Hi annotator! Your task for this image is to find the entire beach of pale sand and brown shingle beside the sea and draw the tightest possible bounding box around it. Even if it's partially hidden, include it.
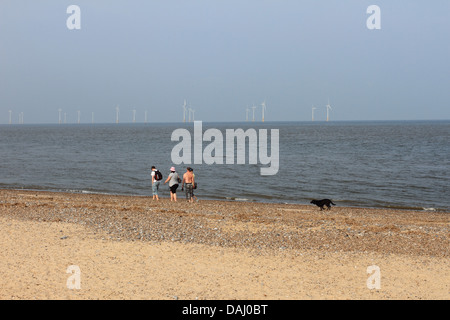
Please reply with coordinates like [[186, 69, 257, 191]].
[[0, 190, 450, 300]]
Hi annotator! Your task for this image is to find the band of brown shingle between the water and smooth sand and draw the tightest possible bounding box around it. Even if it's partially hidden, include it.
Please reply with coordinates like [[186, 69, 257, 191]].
[[0, 190, 450, 257]]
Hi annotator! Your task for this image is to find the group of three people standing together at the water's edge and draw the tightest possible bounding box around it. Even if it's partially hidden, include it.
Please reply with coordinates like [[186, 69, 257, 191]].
[[151, 166, 196, 202]]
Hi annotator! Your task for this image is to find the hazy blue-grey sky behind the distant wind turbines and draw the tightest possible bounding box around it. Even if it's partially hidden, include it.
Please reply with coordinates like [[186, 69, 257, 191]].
[[0, 0, 450, 124]]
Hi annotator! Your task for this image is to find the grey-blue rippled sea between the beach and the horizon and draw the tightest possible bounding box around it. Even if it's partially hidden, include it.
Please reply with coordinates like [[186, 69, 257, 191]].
[[0, 121, 450, 210]]
